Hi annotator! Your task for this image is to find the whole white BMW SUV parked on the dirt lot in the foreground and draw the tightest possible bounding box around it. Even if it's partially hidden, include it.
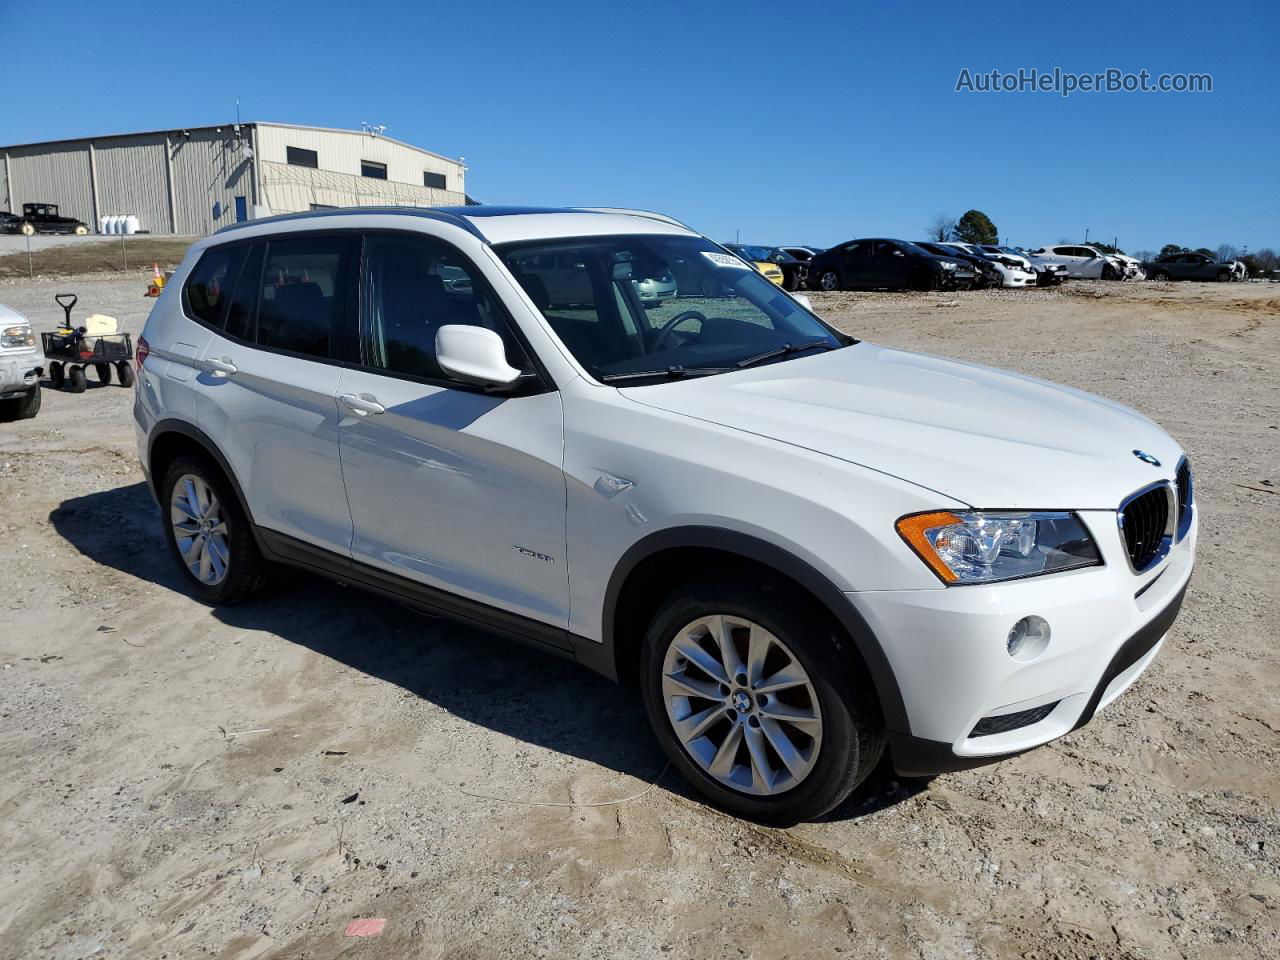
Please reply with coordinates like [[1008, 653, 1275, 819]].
[[136, 206, 1196, 823]]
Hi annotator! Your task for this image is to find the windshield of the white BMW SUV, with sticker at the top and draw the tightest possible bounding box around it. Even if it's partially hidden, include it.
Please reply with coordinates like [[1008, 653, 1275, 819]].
[[495, 236, 850, 383]]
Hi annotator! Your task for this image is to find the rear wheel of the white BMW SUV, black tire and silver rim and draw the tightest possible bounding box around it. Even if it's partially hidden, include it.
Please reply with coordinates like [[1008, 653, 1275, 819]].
[[160, 457, 266, 604]]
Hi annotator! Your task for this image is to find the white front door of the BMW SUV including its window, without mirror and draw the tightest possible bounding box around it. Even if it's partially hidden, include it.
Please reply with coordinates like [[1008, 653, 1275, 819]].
[[338, 233, 568, 627]]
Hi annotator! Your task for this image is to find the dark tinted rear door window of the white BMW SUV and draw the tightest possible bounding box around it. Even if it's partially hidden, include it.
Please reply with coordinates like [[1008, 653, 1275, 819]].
[[257, 234, 351, 358]]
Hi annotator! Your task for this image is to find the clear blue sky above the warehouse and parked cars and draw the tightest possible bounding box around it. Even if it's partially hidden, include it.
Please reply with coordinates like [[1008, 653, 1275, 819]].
[[0, 0, 1280, 250]]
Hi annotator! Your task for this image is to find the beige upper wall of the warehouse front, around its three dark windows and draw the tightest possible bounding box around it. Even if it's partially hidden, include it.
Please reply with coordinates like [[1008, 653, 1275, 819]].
[[257, 123, 466, 195]]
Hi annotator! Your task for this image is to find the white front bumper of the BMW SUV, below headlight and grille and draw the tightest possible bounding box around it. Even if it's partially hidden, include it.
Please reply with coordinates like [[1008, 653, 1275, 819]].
[[849, 511, 1197, 776]]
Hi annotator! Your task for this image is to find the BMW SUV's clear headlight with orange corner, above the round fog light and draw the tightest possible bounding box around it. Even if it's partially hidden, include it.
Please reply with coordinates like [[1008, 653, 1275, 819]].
[[897, 511, 1102, 584]]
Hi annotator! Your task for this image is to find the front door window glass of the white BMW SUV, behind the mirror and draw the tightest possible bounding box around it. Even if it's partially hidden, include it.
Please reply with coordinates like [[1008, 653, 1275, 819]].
[[361, 234, 529, 380]]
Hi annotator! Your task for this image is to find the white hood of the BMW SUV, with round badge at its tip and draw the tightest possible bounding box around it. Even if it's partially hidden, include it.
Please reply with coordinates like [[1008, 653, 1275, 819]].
[[621, 343, 1181, 509]]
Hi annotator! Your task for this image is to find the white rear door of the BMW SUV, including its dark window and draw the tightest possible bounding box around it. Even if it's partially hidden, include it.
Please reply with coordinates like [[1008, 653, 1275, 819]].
[[197, 233, 356, 557]]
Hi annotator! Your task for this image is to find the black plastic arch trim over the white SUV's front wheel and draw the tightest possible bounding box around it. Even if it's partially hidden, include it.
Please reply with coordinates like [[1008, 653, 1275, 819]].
[[602, 526, 911, 733]]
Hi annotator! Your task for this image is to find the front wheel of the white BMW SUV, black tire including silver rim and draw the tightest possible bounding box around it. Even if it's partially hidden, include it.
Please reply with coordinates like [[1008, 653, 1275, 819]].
[[641, 581, 884, 826]]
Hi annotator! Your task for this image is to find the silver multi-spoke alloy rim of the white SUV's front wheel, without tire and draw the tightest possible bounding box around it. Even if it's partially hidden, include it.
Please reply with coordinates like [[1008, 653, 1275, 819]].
[[662, 614, 822, 796]]
